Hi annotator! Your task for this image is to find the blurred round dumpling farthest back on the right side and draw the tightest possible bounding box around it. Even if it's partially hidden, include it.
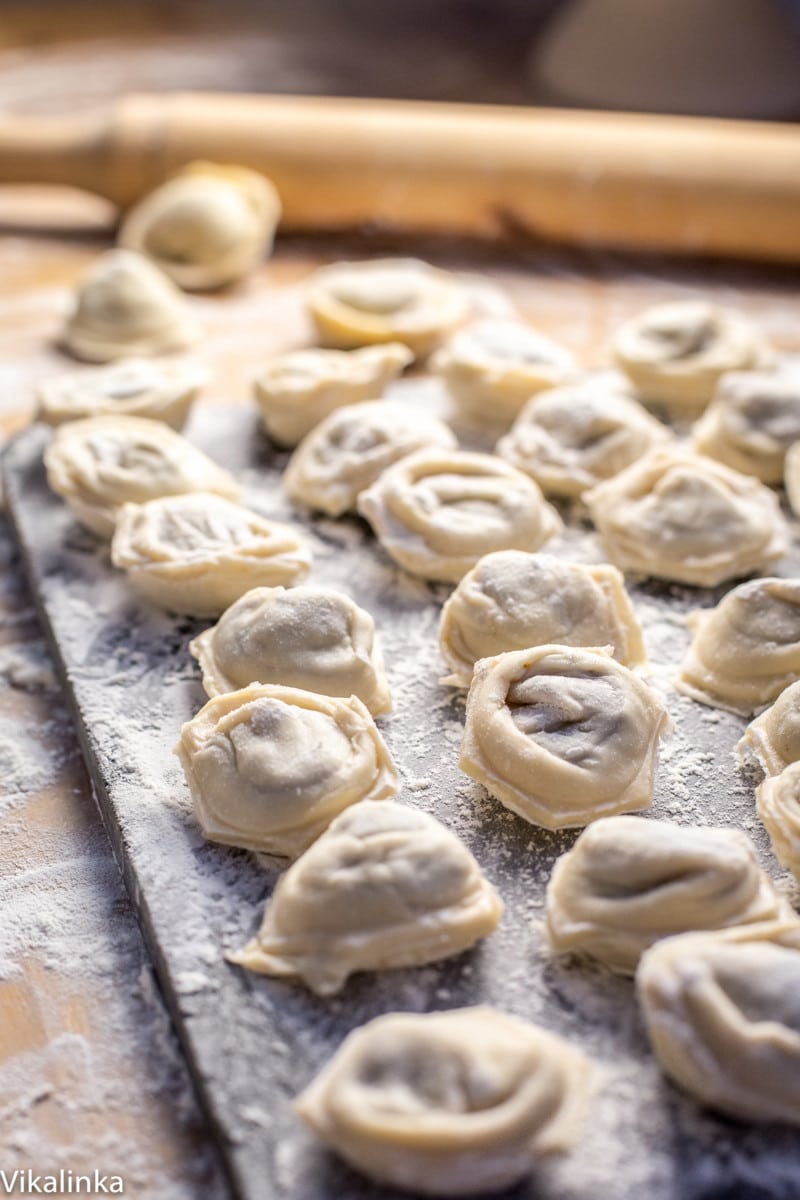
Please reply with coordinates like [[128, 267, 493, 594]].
[[614, 300, 765, 413]]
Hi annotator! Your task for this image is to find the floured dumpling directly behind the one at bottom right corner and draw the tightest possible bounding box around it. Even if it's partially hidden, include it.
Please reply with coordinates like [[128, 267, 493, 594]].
[[547, 817, 790, 974]]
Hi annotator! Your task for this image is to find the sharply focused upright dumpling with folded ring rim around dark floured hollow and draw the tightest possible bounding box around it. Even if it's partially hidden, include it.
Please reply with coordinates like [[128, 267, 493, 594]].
[[459, 646, 668, 829]]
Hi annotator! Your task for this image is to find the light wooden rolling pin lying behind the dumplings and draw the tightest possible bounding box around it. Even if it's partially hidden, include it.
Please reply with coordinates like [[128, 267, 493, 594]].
[[0, 92, 800, 263]]
